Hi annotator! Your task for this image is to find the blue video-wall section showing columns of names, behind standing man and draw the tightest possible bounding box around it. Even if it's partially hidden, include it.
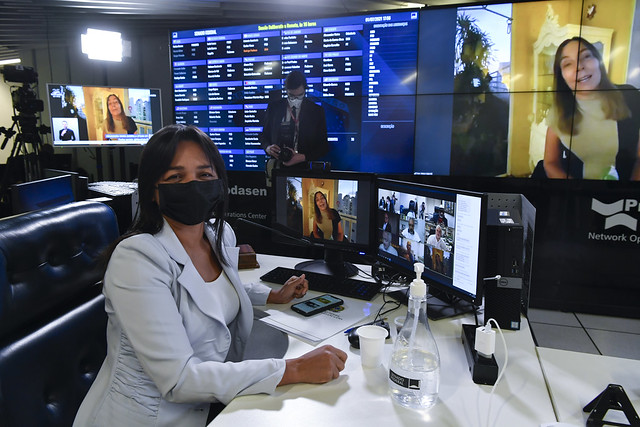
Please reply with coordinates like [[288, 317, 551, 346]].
[[171, 11, 419, 173]]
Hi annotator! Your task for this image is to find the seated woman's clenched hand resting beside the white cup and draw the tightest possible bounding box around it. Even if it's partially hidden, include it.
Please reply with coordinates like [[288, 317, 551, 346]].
[[278, 345, 347, 385]]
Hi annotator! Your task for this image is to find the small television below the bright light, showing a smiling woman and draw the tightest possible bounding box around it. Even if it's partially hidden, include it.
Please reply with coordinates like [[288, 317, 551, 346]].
[[47, 83, 162, 147]]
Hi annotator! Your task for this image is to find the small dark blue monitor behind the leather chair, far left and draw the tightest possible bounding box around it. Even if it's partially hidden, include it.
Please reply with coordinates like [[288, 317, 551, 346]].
[[11, 175, 75, 214]]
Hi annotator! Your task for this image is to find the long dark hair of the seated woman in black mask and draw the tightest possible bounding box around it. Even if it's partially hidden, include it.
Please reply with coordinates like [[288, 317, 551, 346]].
[[104, 125, 234, 267]]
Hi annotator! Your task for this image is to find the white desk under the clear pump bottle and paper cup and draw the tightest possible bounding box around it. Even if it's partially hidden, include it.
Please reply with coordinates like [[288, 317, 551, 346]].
[[209, 255, 556, 427]]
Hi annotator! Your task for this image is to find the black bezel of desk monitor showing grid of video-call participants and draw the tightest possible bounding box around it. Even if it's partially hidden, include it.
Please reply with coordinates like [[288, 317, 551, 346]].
[[372, 177, 488, 307]]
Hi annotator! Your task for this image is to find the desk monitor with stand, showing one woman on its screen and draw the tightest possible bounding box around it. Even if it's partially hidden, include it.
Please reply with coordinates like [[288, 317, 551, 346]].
[[272, 169, 374, 277]]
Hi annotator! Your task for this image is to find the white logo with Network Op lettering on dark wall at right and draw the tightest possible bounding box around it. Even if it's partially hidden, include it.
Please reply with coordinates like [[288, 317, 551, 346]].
[[587, 198, 640, 244]]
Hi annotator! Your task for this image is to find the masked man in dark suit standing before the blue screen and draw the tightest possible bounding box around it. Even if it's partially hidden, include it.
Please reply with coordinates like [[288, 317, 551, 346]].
[[260, 70, 329, 182]]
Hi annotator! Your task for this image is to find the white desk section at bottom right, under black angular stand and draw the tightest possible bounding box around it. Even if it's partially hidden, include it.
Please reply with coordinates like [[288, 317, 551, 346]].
[[538, 347, 640, 426]]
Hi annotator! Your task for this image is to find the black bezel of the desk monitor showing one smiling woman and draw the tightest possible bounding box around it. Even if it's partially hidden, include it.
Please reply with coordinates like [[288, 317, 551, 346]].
[[270, 168, 376, 255]]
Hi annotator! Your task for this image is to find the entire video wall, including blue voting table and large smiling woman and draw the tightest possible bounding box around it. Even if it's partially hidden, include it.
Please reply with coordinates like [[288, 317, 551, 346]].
[[171, 0, 640, 181]]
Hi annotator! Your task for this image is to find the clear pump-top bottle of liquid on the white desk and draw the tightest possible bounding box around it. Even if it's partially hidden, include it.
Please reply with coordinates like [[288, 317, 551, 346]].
[[389, 263, 440, 409]]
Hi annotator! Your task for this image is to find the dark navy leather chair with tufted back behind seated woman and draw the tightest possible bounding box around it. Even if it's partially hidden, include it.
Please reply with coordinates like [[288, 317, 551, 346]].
[[0, 202, 118, 426]]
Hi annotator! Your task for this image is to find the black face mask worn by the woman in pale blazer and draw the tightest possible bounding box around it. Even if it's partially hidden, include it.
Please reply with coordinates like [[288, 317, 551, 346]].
[[158, 179, 223, 225]]
